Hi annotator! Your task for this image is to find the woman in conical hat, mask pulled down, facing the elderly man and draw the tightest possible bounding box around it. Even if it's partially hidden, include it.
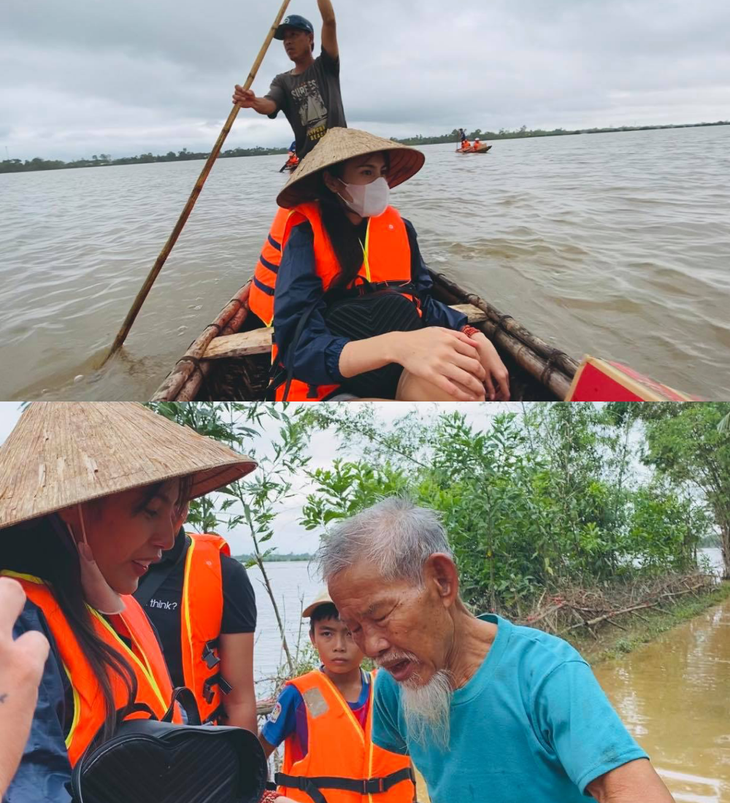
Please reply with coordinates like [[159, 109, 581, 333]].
[[0, 402, 255, 803]]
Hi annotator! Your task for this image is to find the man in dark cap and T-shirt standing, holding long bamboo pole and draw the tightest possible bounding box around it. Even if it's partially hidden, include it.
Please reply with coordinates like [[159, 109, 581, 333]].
[[233, 0, 347, 159]]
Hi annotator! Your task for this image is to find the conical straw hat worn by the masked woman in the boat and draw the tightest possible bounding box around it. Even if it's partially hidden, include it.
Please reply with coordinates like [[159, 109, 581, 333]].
[[276, 128, 426, 209]]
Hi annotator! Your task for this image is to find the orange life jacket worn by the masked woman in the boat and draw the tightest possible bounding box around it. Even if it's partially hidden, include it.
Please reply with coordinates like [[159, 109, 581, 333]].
[[272, 202, 412, 401]]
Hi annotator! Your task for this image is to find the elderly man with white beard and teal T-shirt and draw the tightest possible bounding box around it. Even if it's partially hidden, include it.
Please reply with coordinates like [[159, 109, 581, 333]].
[[319, 499, 672, 803]]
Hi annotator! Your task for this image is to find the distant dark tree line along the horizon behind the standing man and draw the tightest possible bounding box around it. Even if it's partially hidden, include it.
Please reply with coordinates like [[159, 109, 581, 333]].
[[0, 120, 730, 173]]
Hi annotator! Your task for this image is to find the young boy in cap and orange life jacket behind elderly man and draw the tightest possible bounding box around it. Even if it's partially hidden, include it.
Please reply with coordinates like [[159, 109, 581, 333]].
[[259, 593, 415, 803]]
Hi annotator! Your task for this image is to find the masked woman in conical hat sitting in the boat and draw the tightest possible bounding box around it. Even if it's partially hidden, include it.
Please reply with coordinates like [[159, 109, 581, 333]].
[[257, 128, 509, 401]]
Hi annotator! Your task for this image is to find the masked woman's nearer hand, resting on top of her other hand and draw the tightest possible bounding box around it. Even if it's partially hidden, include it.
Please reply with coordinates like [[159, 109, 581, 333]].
[[389, 326, 487, 401]]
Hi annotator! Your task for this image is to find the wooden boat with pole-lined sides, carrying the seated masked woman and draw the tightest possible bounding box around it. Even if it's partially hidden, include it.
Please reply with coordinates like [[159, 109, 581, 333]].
[[153, 271, 578, 401]]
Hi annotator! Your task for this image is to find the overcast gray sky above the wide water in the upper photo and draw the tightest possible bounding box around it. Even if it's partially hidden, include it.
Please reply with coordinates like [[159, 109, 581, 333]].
[[0, 0, 730, 159]]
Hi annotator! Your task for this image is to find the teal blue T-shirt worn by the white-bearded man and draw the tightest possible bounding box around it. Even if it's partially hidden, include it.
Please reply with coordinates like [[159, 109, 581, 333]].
[[373, 614, 648, 803]]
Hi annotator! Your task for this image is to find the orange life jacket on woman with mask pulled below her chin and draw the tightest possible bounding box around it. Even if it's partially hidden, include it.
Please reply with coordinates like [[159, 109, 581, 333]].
[[2, 571, 182, 767]]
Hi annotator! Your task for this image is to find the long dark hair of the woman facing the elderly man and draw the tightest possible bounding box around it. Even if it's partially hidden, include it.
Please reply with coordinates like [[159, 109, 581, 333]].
[[0, 477, 192, 743]]
